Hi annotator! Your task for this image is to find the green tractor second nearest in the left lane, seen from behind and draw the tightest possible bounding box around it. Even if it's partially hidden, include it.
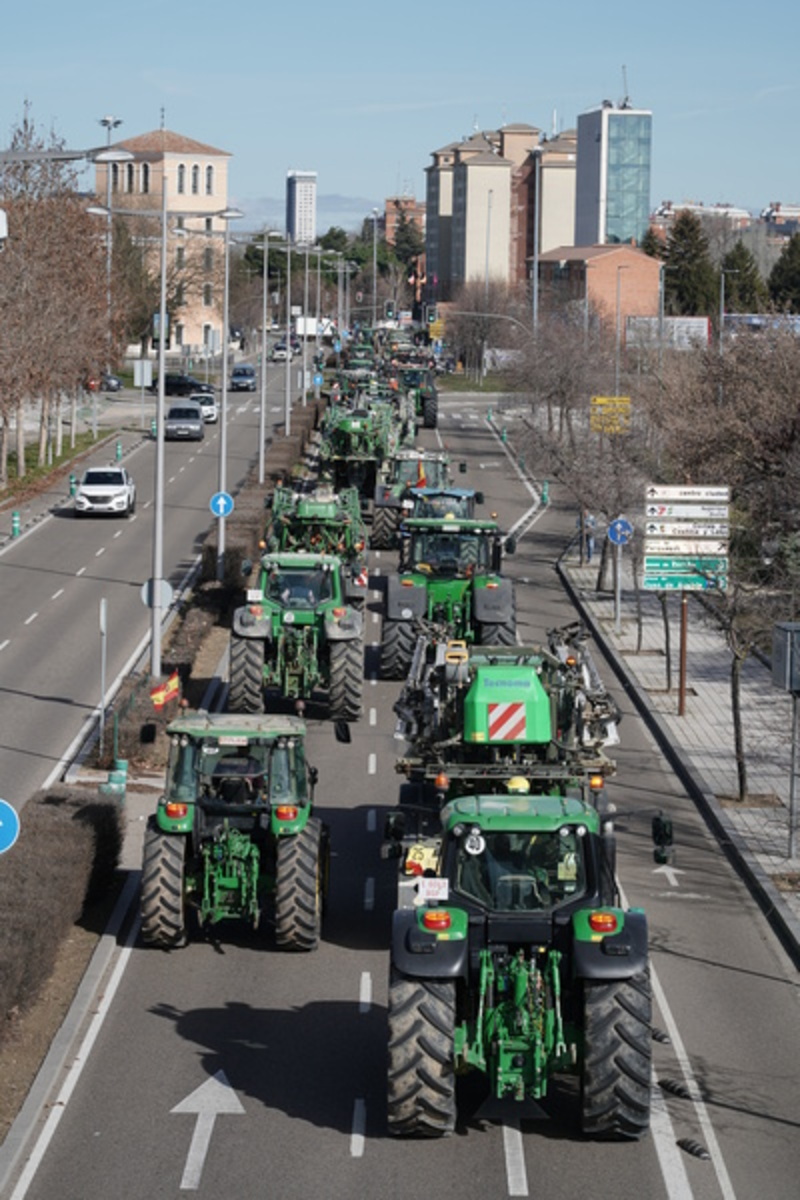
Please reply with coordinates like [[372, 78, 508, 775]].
[[228, 551, 363, 721]]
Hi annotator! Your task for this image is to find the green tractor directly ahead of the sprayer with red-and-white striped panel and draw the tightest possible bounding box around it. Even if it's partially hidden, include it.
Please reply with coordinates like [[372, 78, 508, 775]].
[[380, 517, 517, 679]]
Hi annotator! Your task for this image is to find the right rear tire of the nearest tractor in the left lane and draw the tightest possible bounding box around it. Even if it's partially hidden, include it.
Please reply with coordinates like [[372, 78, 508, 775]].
[[275, 817, 327, 950]]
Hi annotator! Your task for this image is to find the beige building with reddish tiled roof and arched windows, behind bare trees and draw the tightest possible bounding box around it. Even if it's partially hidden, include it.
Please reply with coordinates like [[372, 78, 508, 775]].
[[95, 130, 230, 358]]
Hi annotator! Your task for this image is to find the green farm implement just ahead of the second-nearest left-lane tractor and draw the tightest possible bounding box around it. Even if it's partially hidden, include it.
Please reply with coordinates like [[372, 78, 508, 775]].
[[266, 484, 369, 610]]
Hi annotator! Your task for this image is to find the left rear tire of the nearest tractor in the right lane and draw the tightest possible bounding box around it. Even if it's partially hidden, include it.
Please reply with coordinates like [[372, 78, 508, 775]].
[[387, 967, 456, 1138]]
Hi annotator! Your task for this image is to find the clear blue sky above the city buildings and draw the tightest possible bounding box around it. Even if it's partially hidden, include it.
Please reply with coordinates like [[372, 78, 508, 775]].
[[0, 0, 800, 232]]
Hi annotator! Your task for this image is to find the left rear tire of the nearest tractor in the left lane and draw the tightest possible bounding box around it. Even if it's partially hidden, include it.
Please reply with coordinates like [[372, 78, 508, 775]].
[[140, 817, 187, 950]]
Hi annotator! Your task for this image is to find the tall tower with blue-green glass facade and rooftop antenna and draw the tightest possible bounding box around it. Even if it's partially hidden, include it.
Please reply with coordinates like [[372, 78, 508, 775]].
[[575, 101, 652, 246]]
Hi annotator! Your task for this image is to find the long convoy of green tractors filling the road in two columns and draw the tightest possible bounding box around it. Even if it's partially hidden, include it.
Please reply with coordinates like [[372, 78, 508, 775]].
[[136, 326, 651, 1139]]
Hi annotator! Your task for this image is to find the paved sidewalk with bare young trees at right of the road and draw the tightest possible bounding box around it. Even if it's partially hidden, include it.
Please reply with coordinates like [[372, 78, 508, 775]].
[[559, 546, 800, 966]]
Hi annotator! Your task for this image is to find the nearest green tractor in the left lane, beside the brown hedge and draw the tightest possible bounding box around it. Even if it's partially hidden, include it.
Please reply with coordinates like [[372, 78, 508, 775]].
[[142, 712, 329, 950]]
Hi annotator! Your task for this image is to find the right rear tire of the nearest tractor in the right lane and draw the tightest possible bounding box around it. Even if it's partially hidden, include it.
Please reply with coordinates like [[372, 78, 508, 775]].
[[581, 970, 652, 1139]]
